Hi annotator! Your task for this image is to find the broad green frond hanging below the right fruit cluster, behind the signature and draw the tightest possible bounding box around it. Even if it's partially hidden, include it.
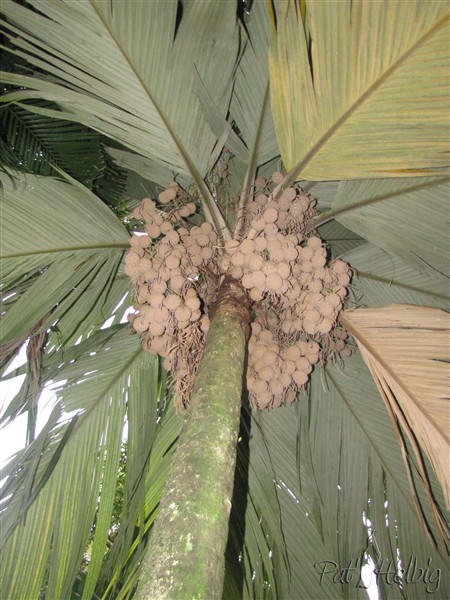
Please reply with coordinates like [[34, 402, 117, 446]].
[[251, 355, 447, 599]]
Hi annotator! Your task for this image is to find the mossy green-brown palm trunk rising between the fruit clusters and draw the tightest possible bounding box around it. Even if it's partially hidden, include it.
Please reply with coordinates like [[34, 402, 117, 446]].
[[136, 278, 250, 600]]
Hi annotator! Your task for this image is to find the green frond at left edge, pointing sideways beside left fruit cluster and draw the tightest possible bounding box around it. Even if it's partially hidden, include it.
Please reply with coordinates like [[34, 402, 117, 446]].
[[0, 169, 129, 354]]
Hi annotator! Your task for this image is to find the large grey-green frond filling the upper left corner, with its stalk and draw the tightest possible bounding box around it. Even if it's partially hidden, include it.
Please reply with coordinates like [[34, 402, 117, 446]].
[[3, 0, 239, 236]]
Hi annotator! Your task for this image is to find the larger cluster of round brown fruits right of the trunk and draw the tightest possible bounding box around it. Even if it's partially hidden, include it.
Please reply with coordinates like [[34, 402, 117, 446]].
[[222, 176, 351, 409]]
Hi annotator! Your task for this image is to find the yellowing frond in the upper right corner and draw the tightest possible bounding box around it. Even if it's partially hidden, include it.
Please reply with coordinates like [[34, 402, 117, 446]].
[[270, 0, 449, 180]]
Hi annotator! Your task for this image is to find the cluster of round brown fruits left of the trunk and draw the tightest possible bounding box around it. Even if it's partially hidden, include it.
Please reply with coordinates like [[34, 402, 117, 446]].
[[125, 187, 219, 404]]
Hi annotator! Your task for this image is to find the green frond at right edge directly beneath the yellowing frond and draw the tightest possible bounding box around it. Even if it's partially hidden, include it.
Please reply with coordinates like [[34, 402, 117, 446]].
[[316, 177, 449, 274]]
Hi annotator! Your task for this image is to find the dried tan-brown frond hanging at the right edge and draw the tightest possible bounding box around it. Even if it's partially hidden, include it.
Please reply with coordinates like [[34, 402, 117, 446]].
[[340, 304, 450, 507]]
